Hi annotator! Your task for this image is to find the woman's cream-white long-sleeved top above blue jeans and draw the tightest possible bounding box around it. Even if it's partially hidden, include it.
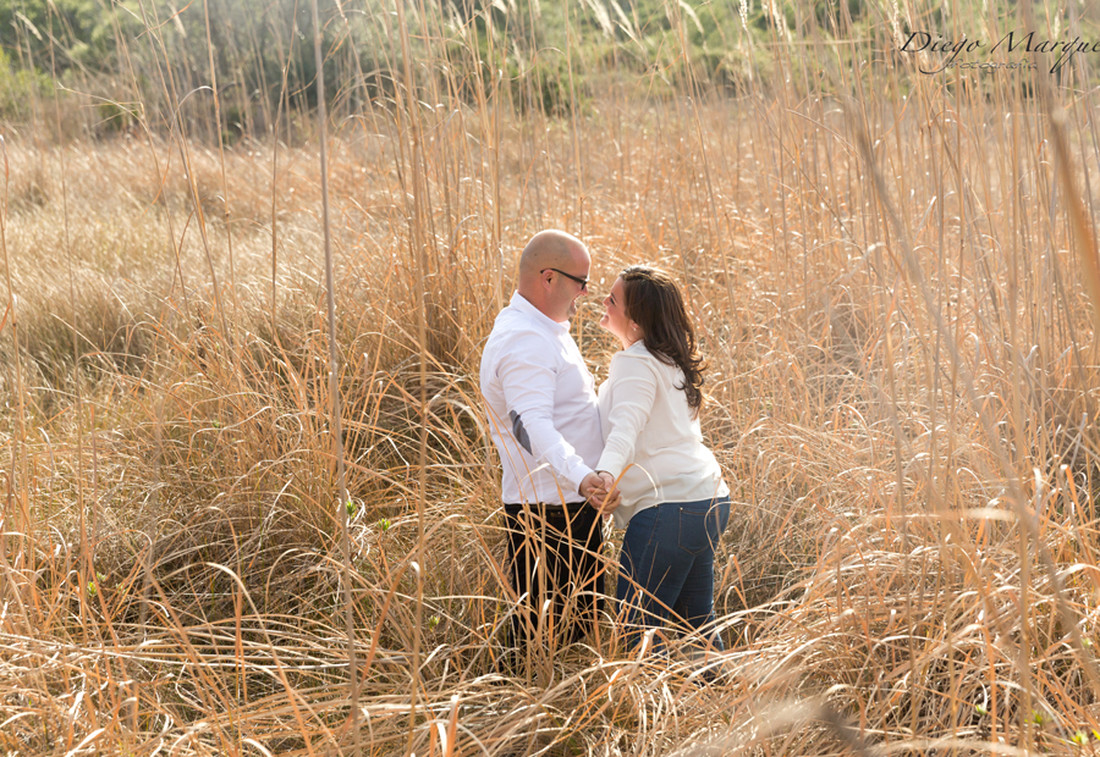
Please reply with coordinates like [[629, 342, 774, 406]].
[[596, 340, 729, 528]]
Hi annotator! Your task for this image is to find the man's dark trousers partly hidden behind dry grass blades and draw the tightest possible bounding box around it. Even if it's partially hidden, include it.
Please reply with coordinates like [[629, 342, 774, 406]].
[[504, 503, 604, 648]]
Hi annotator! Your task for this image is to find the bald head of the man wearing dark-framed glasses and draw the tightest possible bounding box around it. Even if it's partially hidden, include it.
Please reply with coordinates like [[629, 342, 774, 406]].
[[518, 229, 592, 322]]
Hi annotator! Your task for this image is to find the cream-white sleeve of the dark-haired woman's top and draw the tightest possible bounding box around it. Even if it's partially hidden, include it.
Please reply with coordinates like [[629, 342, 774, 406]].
[[596, 352, 657, 478]]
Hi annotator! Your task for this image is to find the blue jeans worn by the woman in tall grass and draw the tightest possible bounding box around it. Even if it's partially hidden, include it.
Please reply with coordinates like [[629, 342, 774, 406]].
[[615, 496, 729, 649]]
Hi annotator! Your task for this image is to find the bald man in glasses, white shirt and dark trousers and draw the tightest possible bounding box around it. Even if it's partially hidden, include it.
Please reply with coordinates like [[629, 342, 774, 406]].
[[481, 229, 617, 645]]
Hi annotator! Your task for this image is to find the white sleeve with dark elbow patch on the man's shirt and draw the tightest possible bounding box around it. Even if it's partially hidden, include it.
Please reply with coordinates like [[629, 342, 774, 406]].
[[497, 340, 592, 494]]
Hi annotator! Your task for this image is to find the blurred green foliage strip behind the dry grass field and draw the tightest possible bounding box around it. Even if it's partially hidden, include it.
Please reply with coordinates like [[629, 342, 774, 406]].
[[0, 0, 1100, 141]]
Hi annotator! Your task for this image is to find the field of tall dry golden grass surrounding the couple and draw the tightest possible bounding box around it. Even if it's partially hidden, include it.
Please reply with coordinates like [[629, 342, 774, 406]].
[[0, 3, 1100, 757]]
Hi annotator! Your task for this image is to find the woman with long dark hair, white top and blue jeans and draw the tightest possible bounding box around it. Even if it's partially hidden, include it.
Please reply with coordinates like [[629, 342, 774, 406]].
[[596, 265, 729, 649]]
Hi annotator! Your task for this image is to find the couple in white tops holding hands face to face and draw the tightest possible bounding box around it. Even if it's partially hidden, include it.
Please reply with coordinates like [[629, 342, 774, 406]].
[[481, 230, 729, 649]]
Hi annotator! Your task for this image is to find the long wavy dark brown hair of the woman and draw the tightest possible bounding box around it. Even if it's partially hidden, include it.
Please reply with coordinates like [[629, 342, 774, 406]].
[[619, 265, 706, 415]]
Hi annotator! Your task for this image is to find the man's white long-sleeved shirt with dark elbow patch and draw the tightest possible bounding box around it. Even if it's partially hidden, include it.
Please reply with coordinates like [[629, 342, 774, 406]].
[[481, 292, 603, 504]]
